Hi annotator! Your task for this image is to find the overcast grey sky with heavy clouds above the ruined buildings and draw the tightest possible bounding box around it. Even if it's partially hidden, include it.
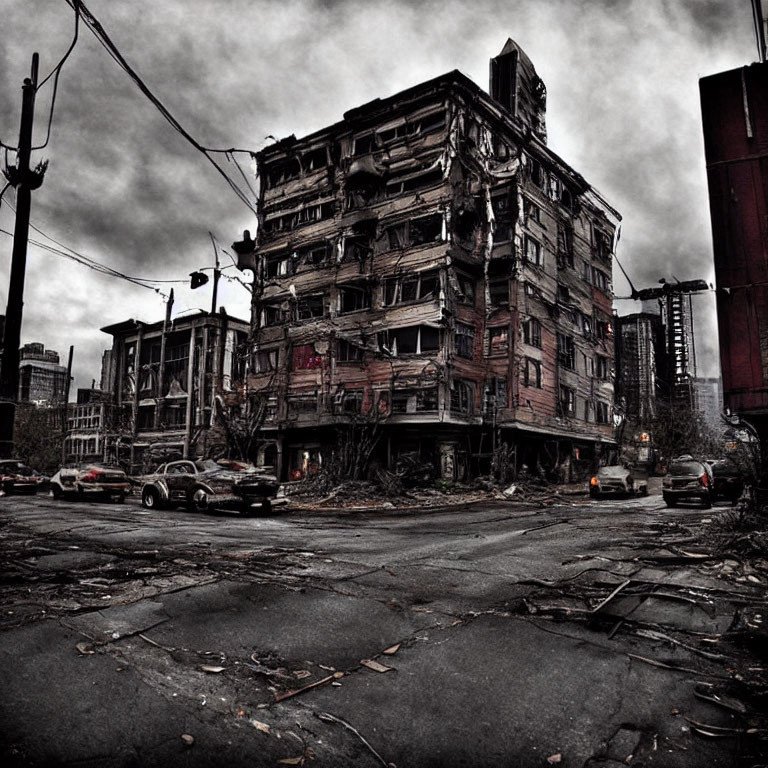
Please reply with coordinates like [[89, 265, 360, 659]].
[[0, 0, 756, 387]]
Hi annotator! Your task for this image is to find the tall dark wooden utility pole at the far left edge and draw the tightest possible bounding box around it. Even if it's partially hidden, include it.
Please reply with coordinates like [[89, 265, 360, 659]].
[[0, 53, 45, 458]]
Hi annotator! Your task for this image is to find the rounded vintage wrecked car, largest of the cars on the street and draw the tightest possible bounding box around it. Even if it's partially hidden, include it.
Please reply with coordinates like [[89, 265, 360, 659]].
[[141, 459, 280, 515]]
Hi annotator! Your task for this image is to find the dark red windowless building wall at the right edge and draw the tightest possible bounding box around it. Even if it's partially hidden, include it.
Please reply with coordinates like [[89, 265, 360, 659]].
[[699, 62, 768, 444]]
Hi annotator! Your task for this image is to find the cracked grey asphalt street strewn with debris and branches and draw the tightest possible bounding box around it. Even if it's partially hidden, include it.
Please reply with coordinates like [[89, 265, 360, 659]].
[[0, 495, 768, 768]]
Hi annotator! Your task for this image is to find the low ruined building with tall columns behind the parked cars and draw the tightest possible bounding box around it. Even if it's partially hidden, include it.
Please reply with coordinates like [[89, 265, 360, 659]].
[[102, 311, 249, 471]]
